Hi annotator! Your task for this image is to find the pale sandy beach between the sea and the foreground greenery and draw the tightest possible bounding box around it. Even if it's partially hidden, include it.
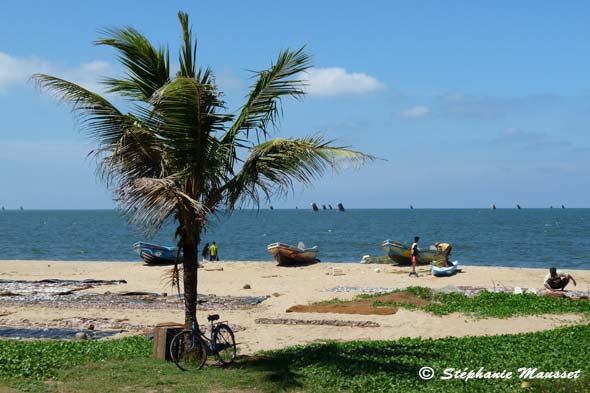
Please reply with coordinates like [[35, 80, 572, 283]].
[[0, 260, 590, 354]]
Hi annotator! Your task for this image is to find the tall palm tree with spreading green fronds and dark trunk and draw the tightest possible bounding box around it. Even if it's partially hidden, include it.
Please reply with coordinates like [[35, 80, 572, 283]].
[[32, 12, 373, 327]]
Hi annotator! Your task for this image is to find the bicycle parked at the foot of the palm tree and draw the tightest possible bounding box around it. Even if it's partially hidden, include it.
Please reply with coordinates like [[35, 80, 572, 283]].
[[170, 314, 236, 371]]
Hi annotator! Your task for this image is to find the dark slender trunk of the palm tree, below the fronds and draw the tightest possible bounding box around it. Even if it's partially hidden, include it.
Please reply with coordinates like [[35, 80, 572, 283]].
[[182, 226, 201, 329]]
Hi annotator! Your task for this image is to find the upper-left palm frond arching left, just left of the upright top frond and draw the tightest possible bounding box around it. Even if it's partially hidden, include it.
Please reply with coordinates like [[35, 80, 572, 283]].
[[95, 27, 170, 101]]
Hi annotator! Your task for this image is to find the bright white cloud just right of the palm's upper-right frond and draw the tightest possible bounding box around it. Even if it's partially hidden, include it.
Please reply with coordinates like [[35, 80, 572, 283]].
[[305, 67, 385, 96]]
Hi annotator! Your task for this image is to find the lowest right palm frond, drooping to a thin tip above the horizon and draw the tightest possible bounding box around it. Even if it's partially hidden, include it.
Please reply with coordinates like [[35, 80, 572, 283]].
[[227, 135, 376, 208]]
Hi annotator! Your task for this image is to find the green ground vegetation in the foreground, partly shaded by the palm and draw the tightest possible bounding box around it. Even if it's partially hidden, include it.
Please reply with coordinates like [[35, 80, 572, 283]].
[[0, 325, 590, 393]]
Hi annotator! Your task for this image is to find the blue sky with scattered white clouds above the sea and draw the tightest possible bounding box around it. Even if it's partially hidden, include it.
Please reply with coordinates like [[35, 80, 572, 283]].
[[0, 0, 590, 209]]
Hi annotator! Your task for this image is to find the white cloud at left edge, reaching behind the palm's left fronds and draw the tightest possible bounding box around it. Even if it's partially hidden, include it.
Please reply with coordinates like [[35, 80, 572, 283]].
[[0, 52, 114, 93]]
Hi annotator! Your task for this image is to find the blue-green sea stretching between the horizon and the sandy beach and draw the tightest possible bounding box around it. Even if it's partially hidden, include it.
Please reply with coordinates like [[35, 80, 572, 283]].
[[0, 208, 590, 269]]
